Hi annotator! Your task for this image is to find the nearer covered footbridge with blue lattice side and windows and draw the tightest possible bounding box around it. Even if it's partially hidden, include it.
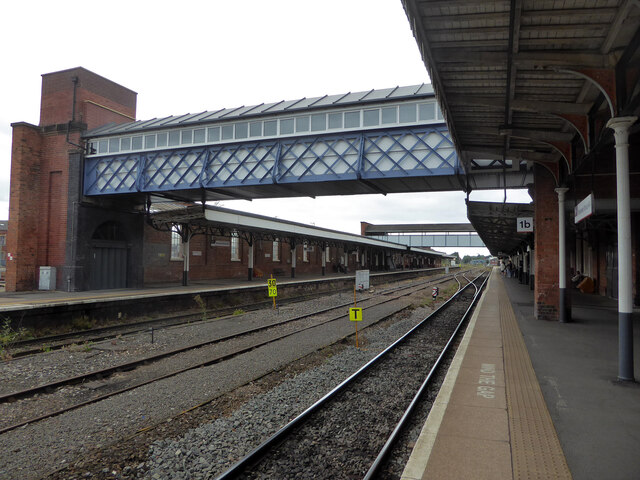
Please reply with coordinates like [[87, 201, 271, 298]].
[[83, 84, 531, 201]]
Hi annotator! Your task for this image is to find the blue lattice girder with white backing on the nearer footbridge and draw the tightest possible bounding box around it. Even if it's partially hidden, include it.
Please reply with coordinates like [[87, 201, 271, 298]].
[[84, 125, 459, 195]]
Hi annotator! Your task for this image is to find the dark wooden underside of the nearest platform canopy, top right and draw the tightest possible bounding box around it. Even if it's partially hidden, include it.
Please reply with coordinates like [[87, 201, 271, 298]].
[[403, 0, 640, 190]]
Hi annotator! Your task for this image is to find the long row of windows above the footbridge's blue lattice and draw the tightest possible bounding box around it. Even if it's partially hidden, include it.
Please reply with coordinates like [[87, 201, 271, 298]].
[[91, 102, 442, 154]]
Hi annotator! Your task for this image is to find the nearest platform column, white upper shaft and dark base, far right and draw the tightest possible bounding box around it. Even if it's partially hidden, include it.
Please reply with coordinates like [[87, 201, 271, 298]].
[[607, 117, 638, 381]]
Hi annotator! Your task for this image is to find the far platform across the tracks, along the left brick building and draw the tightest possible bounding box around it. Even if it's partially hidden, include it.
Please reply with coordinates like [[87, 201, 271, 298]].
[[0, 267, 444, 326]]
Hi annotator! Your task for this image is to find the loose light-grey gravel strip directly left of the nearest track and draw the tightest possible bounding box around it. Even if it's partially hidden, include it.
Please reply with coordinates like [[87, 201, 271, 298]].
[[144, 300, 462, 480]]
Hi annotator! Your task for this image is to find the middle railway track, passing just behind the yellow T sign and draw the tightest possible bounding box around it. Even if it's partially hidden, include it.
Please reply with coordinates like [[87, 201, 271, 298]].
[[0, 270, 470, 434]]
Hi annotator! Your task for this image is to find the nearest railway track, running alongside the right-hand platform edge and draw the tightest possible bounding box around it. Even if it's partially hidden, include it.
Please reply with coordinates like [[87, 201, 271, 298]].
[[212, 275, 486, 480]]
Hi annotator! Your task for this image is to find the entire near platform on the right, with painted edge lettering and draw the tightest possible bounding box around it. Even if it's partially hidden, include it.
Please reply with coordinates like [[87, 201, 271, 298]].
[[402, 269, 640, 480]]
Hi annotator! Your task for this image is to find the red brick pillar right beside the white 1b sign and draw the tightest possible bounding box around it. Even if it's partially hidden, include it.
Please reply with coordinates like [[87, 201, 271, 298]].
[[534, 165, 560, 320]]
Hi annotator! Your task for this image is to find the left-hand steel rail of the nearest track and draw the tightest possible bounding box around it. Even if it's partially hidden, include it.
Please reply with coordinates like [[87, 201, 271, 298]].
[[215, 272, 477, 480]]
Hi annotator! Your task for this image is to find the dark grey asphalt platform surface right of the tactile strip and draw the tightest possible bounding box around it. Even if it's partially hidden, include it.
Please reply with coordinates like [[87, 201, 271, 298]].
[[504, 279, 640, 480]]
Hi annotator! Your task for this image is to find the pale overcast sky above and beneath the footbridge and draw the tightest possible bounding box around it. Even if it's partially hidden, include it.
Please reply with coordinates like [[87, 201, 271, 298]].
[[0, 0, 530, 255]]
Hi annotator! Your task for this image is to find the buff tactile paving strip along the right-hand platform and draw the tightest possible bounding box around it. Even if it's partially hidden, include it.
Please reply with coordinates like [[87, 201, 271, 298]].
[[497, 277, 571, 480]]
